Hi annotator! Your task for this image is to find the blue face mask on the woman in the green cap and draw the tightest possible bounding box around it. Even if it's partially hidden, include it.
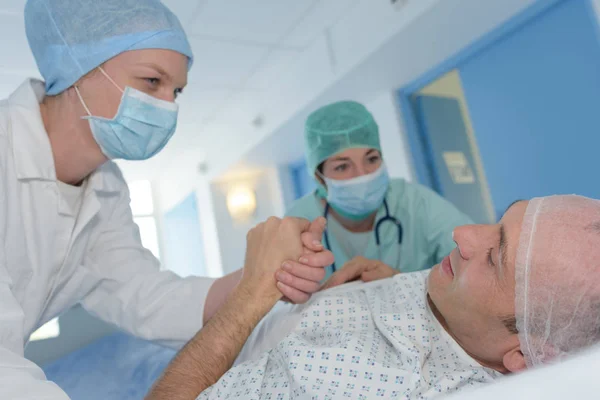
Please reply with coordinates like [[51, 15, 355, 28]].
[[322, 164, 390, 221]]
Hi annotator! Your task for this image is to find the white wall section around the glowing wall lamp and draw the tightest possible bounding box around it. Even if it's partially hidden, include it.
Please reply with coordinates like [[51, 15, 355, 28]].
[[210, 168, 284, 274]]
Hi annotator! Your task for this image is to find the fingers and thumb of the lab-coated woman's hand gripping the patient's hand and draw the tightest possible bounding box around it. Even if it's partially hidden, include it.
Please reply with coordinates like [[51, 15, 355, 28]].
[[276, 217, 334, 304]]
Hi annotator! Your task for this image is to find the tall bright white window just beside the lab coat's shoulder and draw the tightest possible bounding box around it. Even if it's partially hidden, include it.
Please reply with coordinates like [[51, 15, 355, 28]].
[[128, 181, 160, 259]]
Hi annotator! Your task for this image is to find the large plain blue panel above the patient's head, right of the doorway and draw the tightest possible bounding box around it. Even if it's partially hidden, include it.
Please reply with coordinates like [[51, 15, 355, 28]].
[[460, 0, 600, 211]]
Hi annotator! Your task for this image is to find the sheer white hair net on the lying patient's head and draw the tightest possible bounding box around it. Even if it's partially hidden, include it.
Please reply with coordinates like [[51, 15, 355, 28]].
[[515, 196, 600, 367]]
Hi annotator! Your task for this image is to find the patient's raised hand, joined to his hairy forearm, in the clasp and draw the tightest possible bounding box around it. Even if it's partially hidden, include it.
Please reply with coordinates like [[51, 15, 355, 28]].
[[239, 217, 332, 306]]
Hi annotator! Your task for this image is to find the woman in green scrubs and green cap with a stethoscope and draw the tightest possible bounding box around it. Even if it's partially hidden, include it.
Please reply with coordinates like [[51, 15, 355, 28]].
[[281, 101, 471, 284]]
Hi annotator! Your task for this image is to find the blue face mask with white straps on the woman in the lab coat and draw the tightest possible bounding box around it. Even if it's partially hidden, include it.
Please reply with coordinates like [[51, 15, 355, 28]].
[[75, 68, 179, 160]]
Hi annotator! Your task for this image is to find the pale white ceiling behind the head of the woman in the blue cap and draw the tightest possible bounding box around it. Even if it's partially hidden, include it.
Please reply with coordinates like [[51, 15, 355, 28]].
[[0, 0, 356, 179]]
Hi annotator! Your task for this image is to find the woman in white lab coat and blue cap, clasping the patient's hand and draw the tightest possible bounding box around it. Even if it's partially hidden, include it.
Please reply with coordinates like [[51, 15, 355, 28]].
[[0, 0, 333, 400]]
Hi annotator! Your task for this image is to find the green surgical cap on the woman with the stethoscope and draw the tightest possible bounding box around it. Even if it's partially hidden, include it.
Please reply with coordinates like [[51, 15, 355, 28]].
[[304, 101, 381, 175]]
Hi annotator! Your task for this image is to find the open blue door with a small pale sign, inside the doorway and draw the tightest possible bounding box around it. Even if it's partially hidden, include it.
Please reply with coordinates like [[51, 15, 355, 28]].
[[415, 96, 493, 223]]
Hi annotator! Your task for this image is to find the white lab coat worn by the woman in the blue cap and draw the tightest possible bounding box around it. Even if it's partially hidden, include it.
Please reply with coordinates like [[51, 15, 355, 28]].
[[0, 80, 213, 400]]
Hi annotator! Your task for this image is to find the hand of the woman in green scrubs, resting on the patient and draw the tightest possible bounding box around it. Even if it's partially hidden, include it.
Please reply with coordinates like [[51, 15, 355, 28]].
[[321, 256, 400, 290]]
